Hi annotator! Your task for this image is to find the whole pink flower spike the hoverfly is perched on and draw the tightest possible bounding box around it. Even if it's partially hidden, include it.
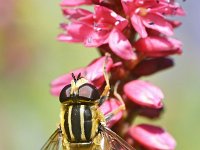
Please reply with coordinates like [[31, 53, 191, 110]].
[[51, 0, 184, 150]]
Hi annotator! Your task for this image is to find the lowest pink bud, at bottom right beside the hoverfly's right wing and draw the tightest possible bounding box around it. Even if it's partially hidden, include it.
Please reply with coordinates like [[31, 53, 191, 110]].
[[128, 124, 176, 150]]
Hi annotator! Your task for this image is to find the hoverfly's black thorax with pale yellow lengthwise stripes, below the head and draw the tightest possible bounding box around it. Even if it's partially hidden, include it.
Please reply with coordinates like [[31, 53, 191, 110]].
[[61, 105, 102, 143]]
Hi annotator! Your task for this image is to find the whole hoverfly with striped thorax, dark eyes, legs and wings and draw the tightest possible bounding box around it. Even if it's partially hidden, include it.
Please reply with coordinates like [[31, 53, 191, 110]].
[[41, 72, 134, 150]]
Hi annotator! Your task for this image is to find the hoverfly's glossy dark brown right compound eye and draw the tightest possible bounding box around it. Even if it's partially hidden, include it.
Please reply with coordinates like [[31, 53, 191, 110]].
[[78, 83, 100, 100]]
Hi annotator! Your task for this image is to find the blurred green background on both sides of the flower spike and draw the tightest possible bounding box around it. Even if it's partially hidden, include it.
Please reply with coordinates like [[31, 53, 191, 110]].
[[0, 0, 200, 150]]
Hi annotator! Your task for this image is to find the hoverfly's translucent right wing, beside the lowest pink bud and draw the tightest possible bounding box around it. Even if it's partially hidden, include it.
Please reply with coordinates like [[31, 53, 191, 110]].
[[100, 125, 136, 150]]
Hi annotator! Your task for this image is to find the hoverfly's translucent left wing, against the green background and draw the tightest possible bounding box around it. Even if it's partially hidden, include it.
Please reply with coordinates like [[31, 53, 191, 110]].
[[41, 128, 62, 150]]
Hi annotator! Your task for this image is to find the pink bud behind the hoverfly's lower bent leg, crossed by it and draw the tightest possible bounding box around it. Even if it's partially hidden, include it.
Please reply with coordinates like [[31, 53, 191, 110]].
[[100, 98, 123, 127]]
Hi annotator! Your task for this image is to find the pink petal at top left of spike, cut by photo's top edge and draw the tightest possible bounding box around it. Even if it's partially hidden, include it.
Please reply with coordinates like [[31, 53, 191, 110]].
[[60, 0, 92, 7]]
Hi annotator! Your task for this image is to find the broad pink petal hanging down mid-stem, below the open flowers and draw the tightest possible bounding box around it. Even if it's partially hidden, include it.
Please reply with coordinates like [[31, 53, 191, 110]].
[[109, 29, 136, 60]]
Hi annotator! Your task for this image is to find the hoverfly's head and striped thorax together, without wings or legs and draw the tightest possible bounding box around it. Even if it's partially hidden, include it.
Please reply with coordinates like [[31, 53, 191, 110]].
[[60, 74, 105, 148]]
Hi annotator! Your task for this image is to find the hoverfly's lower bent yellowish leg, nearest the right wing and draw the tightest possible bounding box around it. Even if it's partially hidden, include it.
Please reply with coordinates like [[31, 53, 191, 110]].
[[105, 81, 126, 122]]
